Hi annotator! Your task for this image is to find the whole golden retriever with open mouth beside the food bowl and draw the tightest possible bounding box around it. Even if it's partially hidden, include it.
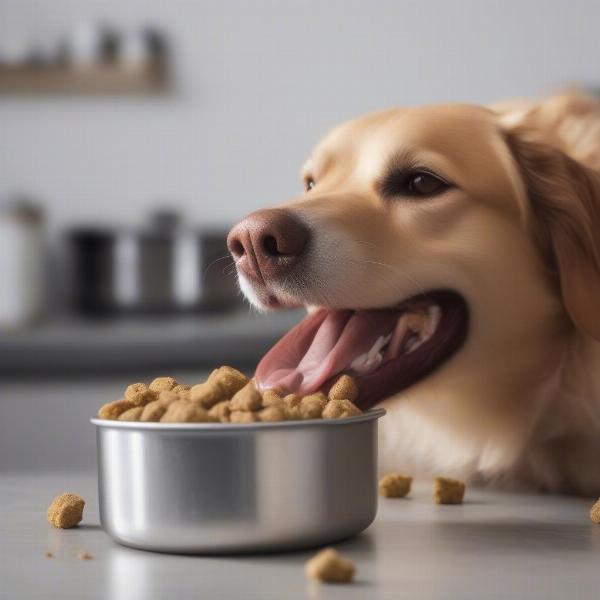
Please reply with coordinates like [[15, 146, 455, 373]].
[[228, 94, 600, 495]]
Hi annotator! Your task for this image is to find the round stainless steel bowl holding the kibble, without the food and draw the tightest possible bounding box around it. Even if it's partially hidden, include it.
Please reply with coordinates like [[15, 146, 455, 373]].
[[92, 409, 385, 553]]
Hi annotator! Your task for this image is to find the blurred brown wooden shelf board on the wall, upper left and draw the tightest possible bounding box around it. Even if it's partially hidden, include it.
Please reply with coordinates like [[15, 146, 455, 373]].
[[0, 62, 168, 95]]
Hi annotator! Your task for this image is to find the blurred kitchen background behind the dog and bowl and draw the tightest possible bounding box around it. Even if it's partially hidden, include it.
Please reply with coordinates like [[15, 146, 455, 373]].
[[0, 0, 600, 470]]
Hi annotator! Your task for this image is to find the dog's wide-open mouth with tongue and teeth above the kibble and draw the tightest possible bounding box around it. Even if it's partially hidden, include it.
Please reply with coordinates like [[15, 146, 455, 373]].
[[256, 290, 469, 409]]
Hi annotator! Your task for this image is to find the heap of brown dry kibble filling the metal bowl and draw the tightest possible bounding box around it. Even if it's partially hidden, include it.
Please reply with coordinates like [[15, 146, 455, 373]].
[[98, 366, 361, 423]]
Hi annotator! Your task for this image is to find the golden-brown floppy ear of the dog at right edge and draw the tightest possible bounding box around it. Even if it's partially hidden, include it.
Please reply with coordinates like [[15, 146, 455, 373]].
[[505, 123, 600, 341]]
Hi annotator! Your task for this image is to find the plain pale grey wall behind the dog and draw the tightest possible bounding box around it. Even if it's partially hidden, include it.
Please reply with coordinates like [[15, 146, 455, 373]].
[[0, 0, 600, 227]]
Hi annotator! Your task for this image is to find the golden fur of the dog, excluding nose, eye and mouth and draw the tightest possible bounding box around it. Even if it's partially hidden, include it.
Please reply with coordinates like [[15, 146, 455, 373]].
[[237, 94, 600, 495]]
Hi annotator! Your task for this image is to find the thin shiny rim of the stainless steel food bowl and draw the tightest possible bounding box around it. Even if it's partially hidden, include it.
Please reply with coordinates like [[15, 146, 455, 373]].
[[90, 408, 386, 433]]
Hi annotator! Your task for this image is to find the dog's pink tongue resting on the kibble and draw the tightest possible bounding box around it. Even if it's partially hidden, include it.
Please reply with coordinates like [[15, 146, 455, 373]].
[[256, 310, 398, 394]]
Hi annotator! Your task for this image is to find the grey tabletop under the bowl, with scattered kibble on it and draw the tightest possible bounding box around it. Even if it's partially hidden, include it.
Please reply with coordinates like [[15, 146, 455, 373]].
[[0, 472, 600, 600]]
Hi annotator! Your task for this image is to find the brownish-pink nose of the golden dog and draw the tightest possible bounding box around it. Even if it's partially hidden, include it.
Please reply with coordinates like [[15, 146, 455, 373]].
[[227, 208, 310, 280]]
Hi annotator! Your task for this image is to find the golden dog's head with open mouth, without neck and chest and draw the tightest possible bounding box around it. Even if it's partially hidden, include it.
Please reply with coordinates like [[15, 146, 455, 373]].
[[228, 97, 600, 405]]
